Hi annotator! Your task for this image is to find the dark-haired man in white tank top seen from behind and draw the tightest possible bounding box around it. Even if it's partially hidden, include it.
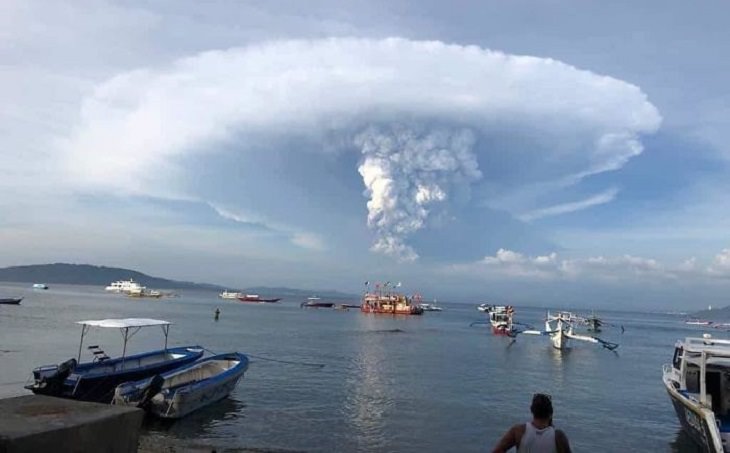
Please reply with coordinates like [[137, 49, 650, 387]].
[[492, 393, 570, 453]]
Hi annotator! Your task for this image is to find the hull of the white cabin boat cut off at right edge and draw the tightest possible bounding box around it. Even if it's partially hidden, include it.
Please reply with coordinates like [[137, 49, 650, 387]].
[[664, 380, 727, 453]]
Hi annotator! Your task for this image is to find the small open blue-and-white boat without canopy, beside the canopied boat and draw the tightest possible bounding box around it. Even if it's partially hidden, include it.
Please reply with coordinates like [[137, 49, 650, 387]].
[[113, 352, 248, 419]]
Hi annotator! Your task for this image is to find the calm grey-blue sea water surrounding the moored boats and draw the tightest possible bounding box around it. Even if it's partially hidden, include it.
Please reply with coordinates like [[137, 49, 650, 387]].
[[0, 284, 708, 452]]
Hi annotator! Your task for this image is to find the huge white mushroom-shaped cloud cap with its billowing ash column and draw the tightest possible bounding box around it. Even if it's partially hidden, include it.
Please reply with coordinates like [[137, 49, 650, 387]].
[[55, 38, 661, 259]]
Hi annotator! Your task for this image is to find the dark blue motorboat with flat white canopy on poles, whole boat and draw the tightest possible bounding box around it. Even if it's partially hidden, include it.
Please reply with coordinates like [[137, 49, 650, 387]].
[[25, 318, 203, 403]]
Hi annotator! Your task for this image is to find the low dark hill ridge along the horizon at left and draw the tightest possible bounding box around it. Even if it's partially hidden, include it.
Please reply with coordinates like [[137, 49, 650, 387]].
[[0, 263, 358, 299]]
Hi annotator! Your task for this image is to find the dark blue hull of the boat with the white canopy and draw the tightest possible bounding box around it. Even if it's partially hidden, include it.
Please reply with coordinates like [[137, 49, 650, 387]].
[[26, 346, 203, 403]]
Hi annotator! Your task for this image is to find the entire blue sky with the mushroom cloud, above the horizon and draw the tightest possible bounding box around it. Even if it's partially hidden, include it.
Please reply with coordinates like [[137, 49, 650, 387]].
[[0, 1, 730, 308]]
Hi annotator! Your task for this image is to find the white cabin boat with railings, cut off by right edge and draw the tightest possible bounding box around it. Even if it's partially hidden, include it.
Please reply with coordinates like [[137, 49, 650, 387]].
[[662, 334, 730, 452]]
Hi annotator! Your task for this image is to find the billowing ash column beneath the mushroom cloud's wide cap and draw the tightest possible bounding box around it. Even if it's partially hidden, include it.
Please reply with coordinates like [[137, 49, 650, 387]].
[[355, 125, 482, 261]]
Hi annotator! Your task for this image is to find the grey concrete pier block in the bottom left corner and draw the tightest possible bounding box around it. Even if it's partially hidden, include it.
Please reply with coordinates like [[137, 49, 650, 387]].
[[0, 395, 144, 453]]
